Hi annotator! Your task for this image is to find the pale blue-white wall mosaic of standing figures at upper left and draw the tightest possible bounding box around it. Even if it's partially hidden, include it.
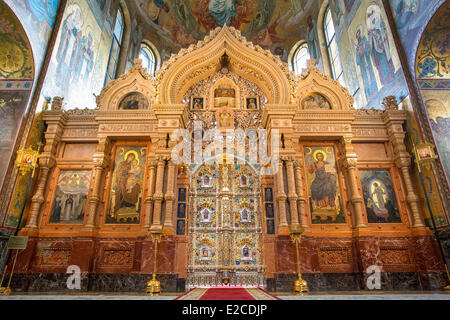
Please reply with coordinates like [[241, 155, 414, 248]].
[[42, 0, 116, 109]]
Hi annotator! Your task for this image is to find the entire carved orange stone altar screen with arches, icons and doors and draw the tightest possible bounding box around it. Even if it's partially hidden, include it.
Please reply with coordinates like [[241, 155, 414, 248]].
[[9, 27, 444, 292]]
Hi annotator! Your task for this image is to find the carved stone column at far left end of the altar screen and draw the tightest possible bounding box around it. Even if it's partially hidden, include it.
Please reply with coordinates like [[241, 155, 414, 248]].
[[25, 110, 65, 229]]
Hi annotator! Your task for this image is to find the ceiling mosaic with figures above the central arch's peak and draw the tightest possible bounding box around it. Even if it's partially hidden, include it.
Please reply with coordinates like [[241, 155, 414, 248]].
[[135, 0, 319, 60]]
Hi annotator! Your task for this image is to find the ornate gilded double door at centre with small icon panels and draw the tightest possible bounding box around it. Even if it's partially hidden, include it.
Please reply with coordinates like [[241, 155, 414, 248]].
[[188, 160, 264, 289]]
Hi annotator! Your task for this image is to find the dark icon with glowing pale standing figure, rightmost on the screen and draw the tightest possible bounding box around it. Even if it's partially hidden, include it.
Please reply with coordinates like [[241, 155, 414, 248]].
[[359, 170, 401, 223]]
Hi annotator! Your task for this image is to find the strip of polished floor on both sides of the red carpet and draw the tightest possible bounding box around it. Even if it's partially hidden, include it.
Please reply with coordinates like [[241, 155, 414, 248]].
[[0, 291, 450, 300]]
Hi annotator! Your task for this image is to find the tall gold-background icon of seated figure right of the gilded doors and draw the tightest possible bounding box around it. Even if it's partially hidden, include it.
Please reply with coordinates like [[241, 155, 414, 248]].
[[304, 146, 345, 224]]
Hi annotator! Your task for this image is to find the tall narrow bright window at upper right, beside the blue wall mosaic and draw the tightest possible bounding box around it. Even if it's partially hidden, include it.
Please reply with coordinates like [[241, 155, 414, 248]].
[[323, 6, 345, 86]]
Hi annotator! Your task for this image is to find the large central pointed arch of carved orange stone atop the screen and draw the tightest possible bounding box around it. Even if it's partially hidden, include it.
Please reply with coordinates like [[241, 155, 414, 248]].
[[156, 26, 290, 104]]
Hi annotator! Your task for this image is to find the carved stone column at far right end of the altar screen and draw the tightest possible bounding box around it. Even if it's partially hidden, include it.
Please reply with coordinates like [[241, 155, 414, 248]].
[[383, 110, 425, 228]]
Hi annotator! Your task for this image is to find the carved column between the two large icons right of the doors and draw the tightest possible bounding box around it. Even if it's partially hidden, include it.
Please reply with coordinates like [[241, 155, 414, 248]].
[[342, 137, 367, 228]]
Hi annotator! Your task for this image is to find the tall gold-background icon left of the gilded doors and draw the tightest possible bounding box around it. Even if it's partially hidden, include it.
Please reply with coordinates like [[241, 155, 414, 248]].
[[106, 146, 147, 224]]
